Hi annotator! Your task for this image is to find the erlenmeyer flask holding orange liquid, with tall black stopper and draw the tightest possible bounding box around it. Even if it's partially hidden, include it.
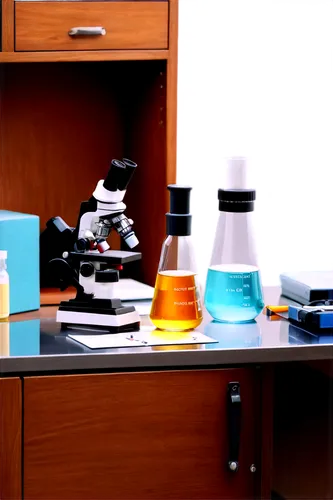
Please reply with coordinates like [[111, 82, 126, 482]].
[[150, 184, 202, 331]]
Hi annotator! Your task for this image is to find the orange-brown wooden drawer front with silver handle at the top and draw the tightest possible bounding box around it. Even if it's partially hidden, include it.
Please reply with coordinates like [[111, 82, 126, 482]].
[[15, 1, 168, 51]]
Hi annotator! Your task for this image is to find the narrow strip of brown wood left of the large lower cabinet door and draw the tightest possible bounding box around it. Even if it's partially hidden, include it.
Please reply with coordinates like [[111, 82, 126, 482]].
[[0, 378, 22, 500]]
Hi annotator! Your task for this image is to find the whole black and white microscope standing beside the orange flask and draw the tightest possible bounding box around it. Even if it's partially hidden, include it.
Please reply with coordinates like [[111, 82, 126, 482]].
[[44, 159, 141, 332]]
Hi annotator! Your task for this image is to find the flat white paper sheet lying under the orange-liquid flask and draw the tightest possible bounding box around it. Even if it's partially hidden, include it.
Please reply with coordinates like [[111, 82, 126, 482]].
[[68, 329, 217, 349]]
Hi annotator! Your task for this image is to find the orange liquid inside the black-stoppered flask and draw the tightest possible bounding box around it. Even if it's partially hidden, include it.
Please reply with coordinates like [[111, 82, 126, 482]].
[[150, 271, 202, 331]]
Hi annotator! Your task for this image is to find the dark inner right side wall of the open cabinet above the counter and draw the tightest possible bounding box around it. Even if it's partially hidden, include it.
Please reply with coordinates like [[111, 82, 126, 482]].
[[125, 61, 169, 286]]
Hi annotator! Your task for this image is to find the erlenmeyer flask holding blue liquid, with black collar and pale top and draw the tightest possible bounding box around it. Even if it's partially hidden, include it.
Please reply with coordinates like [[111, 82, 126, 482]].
[[205, 158, 264, 323]]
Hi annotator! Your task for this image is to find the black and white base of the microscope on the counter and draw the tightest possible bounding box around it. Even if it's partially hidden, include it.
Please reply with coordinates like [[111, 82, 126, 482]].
[[57, 310, 140, 333]]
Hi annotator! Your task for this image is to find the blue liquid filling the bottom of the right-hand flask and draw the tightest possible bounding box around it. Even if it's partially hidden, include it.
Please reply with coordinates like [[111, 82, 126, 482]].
[[205, 264, 264, 323]]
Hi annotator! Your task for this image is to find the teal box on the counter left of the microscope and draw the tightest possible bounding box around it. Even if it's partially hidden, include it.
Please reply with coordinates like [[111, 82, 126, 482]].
[[0, 210, 40, 314]]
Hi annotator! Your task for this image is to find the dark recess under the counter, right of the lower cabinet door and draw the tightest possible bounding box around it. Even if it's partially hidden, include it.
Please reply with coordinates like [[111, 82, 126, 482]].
[[273, 362, 333, 500]]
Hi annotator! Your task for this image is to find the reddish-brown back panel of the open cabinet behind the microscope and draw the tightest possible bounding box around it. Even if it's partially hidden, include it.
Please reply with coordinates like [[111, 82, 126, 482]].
[[0, 63, 124, 230]]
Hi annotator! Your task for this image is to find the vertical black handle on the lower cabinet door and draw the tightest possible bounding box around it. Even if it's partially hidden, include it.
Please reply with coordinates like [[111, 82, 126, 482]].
[[227, 382, 242, 472]]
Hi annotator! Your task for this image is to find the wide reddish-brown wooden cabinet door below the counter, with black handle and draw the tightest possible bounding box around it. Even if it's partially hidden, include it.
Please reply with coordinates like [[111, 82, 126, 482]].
[[24, 368, 260, 500]]
